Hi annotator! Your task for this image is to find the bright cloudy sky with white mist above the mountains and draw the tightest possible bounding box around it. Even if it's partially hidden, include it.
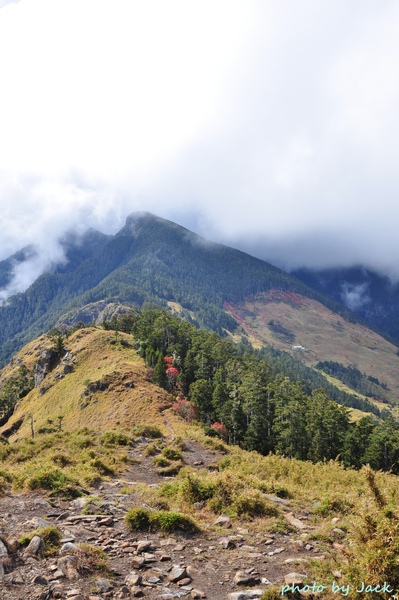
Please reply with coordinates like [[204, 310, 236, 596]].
[[0, 0, 399, 292]]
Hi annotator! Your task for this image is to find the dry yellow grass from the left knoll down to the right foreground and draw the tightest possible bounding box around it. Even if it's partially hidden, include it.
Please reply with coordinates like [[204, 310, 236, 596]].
[[0, 328, 399, 598]]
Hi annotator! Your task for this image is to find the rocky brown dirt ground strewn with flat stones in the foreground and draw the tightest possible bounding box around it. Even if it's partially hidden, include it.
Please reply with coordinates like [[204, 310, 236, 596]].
[[0, 440, 324, 600]]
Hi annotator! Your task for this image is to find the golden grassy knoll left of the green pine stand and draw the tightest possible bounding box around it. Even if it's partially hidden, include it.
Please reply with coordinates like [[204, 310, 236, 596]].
[[0, 328, 171, 439]]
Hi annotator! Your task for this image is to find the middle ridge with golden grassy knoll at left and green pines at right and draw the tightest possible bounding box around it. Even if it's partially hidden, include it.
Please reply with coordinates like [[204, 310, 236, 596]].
[[0, 310, 399, 473]]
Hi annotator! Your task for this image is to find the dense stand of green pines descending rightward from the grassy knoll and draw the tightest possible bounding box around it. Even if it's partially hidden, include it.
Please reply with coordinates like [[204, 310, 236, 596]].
[[116, 310, 399, 473]]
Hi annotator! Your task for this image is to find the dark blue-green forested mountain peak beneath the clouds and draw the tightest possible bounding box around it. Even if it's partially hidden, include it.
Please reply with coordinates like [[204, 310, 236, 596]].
[[0, 212, 354, 363]]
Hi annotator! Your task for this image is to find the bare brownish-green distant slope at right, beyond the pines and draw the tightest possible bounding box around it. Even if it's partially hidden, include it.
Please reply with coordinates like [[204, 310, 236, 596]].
[[227, 294, 399, 403]]
